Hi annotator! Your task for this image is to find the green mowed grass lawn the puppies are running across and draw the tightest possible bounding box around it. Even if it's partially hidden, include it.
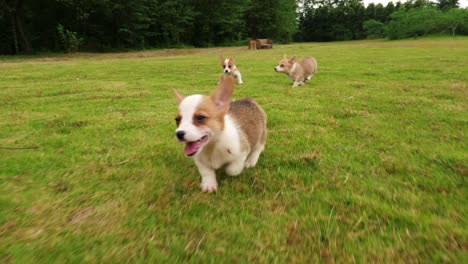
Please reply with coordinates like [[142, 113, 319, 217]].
[[0, 37, 468, 263]]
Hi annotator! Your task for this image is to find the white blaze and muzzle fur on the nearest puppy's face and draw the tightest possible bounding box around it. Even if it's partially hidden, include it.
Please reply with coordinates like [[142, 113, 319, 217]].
[[176, 94, 207, 142]]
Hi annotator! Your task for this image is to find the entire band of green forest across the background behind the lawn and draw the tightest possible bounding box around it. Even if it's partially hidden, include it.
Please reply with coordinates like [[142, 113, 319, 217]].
[[0, 0, 468, 54]]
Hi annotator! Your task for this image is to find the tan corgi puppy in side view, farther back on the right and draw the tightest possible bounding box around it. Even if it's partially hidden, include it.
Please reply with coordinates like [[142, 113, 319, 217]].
[[275, 55, 317, 87]]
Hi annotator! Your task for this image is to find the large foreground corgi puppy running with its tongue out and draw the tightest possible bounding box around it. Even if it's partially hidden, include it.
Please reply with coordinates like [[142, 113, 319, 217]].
[[173, 77, 267, 192]]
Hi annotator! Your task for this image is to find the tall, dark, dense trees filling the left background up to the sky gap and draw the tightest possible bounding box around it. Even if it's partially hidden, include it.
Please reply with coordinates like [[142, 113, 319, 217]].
[[0, 0, 297, 54]]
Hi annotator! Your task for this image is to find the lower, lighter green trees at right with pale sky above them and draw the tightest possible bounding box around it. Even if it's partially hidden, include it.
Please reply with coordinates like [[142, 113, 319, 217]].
[[295, 0, 468, 41]]
